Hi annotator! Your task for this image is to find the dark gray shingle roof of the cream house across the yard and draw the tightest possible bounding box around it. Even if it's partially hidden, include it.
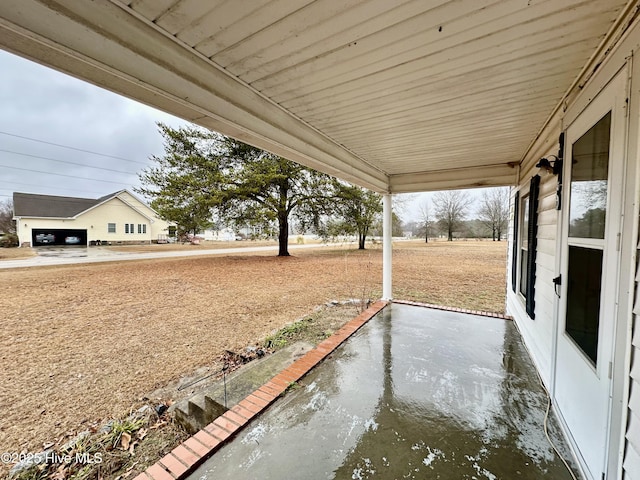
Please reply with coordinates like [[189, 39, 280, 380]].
[[13, 192, 118, 218]]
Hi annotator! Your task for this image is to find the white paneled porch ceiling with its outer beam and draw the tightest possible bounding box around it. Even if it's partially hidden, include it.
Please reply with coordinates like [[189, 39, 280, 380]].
[[0, 0, 636, 192]]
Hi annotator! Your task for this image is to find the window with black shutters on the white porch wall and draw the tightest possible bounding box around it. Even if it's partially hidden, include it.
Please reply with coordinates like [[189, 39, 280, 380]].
[[511, 175, 540, 320]]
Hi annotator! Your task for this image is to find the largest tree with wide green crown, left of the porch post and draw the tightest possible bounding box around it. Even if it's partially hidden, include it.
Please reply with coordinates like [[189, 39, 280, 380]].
[[137, 124, 333, 256]]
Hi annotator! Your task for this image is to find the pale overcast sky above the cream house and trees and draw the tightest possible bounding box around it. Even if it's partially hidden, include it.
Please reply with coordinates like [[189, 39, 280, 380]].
[[0, 50, 490, 221]]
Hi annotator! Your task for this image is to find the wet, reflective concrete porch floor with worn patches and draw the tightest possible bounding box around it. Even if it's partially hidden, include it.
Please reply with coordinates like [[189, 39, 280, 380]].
[[190, 304, 572, 480]]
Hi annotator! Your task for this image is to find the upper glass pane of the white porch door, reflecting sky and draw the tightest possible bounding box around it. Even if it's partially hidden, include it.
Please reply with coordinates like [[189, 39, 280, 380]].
[[569, 113, 611, 238]]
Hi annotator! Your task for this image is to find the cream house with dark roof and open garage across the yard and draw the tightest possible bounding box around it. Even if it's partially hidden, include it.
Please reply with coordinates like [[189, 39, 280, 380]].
[[13, 190, 171, 246]]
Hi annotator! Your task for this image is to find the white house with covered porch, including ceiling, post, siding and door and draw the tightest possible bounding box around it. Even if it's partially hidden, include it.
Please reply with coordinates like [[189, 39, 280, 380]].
[[0, 0, 640, 480]]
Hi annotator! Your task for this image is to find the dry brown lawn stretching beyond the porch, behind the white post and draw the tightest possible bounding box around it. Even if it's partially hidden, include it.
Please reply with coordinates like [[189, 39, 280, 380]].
[[0, 241, 506, 468]]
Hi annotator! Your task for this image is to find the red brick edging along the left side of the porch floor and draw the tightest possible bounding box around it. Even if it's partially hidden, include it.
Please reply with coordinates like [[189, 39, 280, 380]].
[[133, 300, 388, 480]]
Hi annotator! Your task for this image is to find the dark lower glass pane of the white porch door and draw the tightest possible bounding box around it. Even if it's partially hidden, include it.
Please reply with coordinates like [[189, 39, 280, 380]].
[[565, 246, 602, 364]]
